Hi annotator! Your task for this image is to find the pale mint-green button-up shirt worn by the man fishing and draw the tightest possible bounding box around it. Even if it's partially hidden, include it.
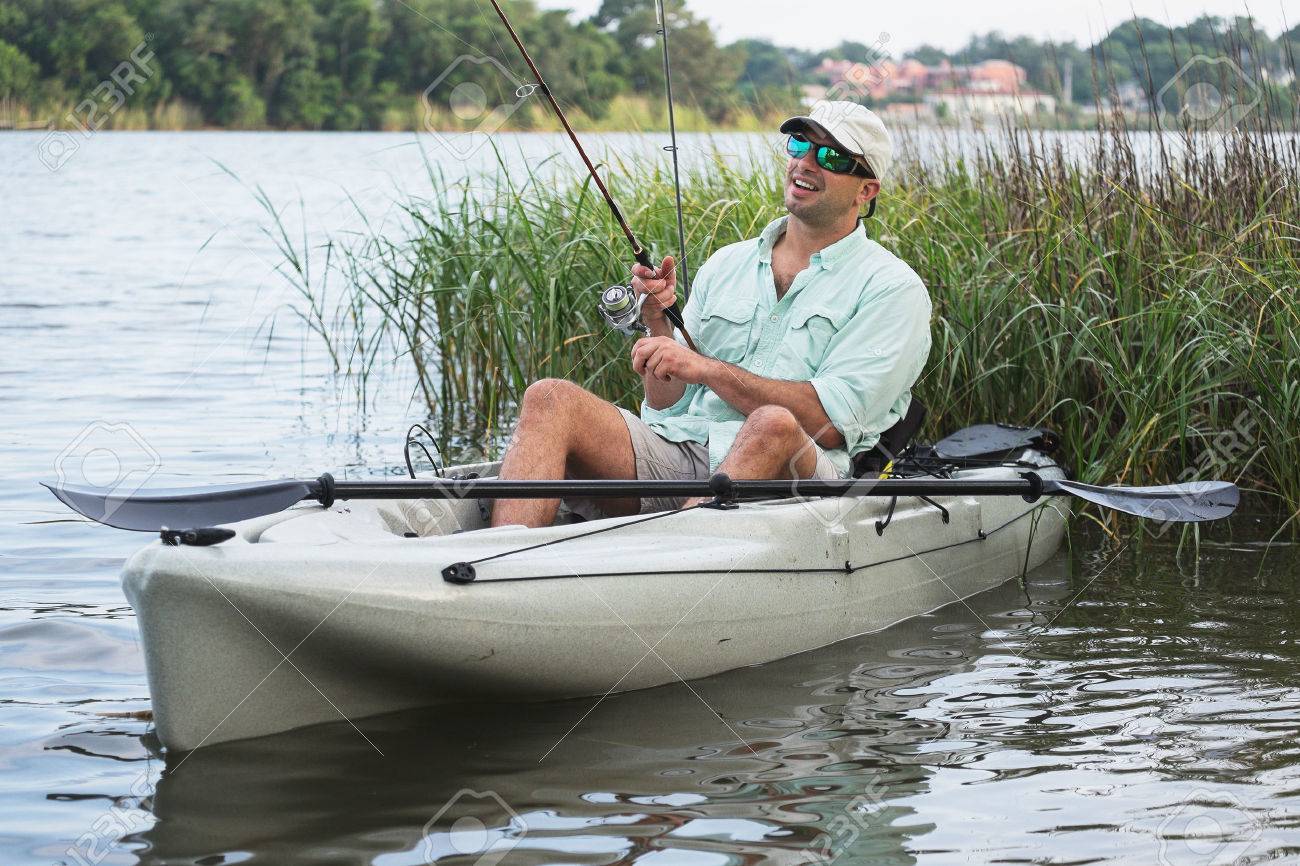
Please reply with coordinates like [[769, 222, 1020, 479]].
[[641, 217, 931, 476]]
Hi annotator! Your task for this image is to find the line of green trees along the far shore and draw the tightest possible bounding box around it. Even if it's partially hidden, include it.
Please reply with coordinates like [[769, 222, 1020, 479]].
[[0, 0, 1300, 130]]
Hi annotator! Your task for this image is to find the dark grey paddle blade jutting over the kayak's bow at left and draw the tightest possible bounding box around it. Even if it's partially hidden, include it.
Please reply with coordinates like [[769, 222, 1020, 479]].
[[44, 480, 313, 532]]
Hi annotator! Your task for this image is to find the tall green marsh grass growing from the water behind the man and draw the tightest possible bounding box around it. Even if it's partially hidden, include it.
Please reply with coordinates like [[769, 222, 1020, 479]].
[[281, 121, 1300, 528]]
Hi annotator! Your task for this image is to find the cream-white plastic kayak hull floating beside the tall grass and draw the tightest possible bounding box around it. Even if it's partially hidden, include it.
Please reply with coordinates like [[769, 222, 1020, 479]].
[[122, 460, 1066, 750]]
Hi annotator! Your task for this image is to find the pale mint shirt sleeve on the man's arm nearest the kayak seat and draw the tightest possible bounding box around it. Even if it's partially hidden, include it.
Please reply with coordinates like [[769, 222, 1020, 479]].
[[811, 278, 931, 455]]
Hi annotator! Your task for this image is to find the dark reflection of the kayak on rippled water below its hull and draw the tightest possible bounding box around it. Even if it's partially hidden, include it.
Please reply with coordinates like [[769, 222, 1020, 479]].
[[138, 569, 1067, 866]]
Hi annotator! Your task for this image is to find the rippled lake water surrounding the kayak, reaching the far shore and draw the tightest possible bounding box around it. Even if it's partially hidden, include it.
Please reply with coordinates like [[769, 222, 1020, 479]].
[[0, 133, 1300, 866]]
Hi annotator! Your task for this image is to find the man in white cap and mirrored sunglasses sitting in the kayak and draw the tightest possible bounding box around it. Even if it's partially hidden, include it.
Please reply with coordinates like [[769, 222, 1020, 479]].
[[491, 101, 930, 527]]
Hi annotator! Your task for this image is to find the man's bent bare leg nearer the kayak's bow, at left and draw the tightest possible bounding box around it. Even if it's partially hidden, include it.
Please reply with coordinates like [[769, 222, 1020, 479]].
[[491, 378, 640, 527]]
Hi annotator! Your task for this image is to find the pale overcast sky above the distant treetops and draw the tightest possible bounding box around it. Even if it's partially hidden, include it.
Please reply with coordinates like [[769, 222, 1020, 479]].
[[540, 0, 1300, 53]]
